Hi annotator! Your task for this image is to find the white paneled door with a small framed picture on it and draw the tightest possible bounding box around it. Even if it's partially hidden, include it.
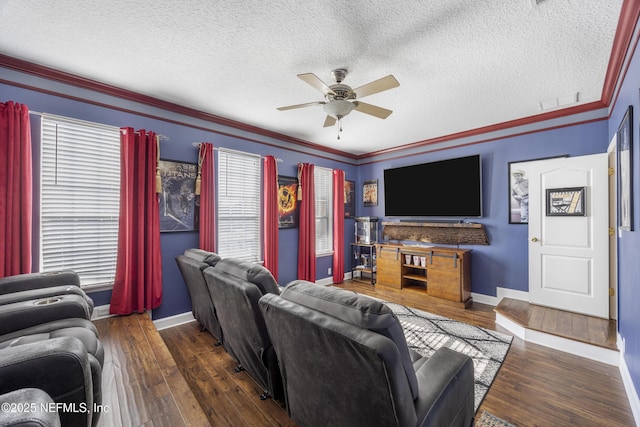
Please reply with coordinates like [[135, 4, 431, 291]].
[[527, 153, 609, 319]]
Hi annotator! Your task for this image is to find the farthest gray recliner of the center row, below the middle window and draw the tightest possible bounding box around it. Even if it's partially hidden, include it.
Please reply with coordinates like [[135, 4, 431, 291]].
[[176, 249, 223, 344]]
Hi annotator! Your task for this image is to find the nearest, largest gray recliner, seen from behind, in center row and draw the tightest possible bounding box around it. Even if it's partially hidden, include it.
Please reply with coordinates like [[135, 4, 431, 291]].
[[259, 281, 474, 427]]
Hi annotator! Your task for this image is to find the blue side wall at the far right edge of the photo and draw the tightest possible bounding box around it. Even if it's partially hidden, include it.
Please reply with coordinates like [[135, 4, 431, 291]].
[[609, 15, 640, 404]]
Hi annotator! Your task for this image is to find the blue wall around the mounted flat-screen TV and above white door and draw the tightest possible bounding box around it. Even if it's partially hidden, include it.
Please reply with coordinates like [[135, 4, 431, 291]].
[[358, 119, 609, 296]]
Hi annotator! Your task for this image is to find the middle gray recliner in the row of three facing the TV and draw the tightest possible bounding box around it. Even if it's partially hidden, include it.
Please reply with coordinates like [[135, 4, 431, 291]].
[[204, 258, 282, 399]]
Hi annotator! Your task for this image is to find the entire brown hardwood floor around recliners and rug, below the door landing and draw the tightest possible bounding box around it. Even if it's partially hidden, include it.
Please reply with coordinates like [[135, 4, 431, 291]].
[[96, 281, 635, 427]]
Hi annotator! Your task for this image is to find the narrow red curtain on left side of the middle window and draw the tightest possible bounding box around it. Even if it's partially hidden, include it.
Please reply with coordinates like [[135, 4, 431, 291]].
[[199, 142, 216, 252]]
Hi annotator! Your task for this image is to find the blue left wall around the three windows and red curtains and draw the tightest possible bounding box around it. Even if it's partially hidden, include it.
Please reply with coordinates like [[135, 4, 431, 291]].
[[0, 80, 356, 319]]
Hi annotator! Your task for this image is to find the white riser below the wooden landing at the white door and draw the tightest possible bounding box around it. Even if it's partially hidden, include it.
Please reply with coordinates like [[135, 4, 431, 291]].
[[496, 313, 620, 366]]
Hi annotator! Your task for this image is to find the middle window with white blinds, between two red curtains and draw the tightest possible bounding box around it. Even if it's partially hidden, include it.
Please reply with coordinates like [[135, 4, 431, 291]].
[[217, 149, 262, 262]]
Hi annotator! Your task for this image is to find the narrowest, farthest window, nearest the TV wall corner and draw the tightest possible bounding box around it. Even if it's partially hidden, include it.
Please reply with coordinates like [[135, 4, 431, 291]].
[[313, 166, 333, 255]]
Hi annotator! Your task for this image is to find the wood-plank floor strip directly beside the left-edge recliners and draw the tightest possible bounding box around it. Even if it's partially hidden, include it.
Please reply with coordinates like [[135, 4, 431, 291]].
[[94, 313, 210, 427]]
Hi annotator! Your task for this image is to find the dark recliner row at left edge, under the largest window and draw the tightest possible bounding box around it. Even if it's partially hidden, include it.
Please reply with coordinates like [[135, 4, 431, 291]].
[[0, 271, 104, 427]]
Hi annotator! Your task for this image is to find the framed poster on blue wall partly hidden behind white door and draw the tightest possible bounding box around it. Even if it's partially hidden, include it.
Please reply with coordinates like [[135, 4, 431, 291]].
[[507, 154, 568, 224]]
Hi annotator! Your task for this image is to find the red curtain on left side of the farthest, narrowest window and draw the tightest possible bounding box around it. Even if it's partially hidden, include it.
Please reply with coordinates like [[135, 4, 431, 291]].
[[298, 163, 316, 282]]
